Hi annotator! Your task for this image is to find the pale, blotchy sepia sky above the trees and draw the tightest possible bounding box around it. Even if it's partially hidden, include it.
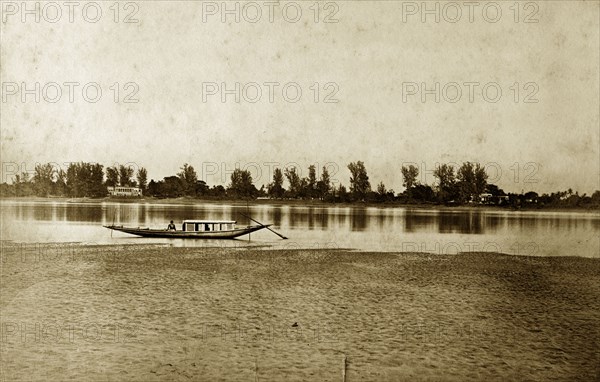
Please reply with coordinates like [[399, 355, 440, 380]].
[[0, 1, 600, 194]]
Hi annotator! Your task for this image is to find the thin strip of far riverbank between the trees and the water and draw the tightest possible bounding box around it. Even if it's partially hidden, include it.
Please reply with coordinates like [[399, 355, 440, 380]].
[[0, 196, 600, 213]]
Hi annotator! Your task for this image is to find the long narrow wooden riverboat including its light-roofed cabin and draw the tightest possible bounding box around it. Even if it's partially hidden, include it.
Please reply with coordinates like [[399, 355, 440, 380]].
[[104, 220, 271, 239]]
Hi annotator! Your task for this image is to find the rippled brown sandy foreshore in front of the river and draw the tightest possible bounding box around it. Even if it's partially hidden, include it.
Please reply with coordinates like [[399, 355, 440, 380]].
[[0, 245, 600, 381]]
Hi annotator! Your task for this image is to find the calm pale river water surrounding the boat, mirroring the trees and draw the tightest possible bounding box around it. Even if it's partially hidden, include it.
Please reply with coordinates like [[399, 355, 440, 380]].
[[0, 200, 600, 258]]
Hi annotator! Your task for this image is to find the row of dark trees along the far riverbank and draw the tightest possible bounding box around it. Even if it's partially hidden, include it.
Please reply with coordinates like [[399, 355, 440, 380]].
[[0, 161, 600, 208]]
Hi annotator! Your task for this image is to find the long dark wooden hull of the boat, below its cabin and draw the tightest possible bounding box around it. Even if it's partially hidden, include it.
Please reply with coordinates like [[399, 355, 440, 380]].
[[103, 224, 270, 239]]
